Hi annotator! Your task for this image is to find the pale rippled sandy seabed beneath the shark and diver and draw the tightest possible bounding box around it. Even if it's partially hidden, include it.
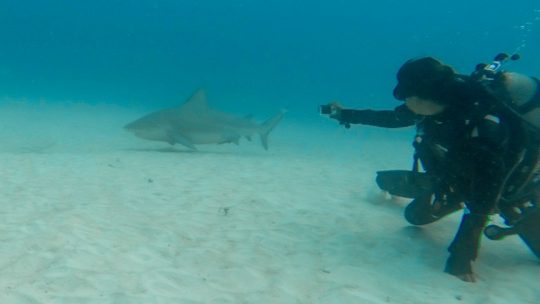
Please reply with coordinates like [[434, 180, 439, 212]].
[[0, 102, 540, 304]]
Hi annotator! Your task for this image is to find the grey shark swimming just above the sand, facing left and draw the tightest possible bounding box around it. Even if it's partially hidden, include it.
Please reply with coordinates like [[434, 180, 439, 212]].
[[124, 90, 284, 150]]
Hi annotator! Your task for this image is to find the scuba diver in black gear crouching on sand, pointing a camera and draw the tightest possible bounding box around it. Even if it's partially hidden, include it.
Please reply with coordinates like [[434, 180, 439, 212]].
[[321, 54, 540, 282]]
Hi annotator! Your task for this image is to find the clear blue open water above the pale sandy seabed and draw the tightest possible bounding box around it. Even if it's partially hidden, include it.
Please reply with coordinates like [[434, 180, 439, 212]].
[[0, 0, 540, 116]]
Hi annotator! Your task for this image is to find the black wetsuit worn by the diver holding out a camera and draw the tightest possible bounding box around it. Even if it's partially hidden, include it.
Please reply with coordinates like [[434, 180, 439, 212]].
[[340, 78, 527, 275]]
